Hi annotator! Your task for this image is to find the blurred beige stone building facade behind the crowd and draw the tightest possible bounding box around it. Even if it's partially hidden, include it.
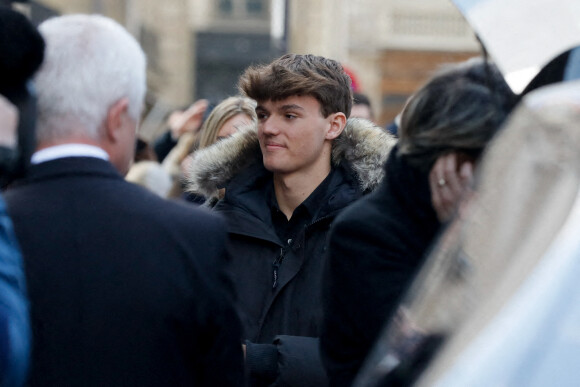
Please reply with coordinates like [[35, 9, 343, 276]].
[[33, 0, 479, 131]]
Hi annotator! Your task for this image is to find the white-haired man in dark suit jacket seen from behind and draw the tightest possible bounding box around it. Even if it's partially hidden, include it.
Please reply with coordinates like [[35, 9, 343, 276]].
[[6, 15, 243, 386]]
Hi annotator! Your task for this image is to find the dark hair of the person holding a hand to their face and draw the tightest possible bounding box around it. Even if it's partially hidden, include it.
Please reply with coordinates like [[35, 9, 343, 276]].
[[399, 58, 516, 170]]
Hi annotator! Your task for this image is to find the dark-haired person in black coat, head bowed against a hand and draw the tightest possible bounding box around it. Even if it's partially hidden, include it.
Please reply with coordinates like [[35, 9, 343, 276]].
[[321, 59, 515, 386]]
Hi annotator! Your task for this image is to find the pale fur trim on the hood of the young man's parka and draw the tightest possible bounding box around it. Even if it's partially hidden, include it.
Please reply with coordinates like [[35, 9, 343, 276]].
[[186, 118, 397, 198]]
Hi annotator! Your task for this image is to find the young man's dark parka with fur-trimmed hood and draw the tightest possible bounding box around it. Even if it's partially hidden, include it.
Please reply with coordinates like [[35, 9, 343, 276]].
[[190, 120, 395, 386]]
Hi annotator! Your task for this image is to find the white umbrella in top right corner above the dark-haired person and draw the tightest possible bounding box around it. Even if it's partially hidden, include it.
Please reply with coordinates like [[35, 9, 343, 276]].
[[452, 0, 580, 94]]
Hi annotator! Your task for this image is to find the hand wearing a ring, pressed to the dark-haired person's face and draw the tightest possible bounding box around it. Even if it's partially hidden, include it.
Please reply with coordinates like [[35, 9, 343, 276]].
[[429, 153, 473, 223]]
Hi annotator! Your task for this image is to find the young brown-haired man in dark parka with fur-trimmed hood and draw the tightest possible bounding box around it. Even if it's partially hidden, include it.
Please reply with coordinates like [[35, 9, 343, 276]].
[[190, 55, 395, 386]]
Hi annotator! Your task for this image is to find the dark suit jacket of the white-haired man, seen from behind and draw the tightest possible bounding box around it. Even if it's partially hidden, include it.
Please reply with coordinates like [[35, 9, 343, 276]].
[[6, 157, 243, 386]]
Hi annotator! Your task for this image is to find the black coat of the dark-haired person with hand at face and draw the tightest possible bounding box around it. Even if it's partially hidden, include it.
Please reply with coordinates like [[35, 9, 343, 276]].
[[321, 147, 440, 386]]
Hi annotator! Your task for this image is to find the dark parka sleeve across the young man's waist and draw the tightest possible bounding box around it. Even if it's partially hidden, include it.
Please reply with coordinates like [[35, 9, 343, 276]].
[[246, 335, 328, 387]]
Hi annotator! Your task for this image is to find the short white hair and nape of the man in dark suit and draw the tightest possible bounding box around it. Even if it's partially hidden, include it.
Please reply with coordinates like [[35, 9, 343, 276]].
[[35, 15, 146, 171]]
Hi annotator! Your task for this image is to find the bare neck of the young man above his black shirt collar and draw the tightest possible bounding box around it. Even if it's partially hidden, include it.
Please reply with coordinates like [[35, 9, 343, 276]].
[[274, 162, 330, 219]]
